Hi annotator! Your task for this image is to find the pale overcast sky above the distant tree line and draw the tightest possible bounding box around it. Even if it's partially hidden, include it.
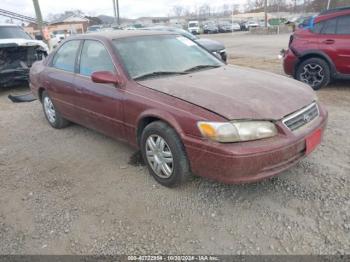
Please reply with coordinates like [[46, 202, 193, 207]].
[[0, 0, 246, 20]]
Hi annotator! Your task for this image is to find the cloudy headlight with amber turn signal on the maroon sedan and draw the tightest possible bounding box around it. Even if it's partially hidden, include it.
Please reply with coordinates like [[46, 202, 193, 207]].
[[198, 121, 277, 143]]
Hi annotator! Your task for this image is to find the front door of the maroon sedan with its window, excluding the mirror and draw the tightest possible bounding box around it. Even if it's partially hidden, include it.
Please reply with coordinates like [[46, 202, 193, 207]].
[[74, 40, 125, 139]]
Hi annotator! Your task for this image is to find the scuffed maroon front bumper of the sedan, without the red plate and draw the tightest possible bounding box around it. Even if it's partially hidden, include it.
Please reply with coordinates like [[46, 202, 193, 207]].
[[184, 103, 328, 184]]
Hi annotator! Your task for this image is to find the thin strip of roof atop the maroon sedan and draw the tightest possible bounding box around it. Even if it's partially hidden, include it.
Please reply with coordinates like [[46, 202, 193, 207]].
[[75, 30, 176, 40]]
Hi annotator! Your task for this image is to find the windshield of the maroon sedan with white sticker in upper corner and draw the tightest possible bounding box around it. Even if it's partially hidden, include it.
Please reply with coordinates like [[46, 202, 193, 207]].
[[113, 35, 223, 79]]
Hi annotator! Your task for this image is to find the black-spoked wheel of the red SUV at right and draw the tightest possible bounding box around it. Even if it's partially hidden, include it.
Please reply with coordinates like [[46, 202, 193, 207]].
[[295, 58, 331, 90]]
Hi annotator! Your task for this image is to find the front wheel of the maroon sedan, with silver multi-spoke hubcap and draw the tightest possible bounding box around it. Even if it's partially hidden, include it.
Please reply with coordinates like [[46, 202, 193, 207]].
[[140, 121, 191, 187]]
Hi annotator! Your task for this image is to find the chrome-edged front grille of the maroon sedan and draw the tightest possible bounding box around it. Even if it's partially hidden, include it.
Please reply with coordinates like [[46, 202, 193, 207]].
[[282, 103, 320, 131]]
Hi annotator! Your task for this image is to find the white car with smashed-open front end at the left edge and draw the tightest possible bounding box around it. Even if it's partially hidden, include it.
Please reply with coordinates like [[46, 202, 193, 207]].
[[0, 24, 49, 87]]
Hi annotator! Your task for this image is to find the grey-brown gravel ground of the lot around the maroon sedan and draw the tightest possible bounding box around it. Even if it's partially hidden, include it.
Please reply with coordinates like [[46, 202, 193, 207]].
[[0, 33, 350, 254]]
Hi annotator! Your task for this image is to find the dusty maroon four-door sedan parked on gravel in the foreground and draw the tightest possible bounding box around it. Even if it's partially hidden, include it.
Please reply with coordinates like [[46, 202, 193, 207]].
[[30, 31, 327, 186]]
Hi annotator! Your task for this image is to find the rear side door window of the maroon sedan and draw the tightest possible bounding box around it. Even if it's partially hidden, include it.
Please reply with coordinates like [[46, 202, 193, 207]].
[[52, 40, 80, 72]]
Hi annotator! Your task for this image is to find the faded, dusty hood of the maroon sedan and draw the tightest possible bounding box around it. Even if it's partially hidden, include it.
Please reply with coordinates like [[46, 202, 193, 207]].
[[139, 66, 316, 120]]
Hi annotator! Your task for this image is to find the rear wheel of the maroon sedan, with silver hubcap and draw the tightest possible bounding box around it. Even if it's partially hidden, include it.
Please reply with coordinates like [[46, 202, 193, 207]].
[[41, 91, 69, 129]]
